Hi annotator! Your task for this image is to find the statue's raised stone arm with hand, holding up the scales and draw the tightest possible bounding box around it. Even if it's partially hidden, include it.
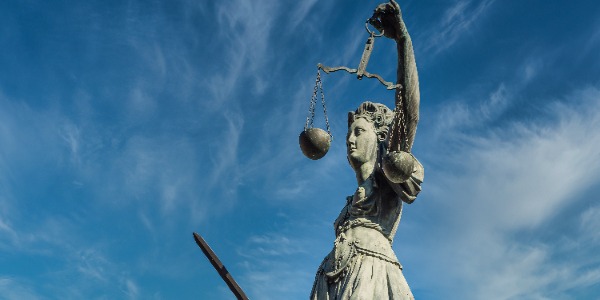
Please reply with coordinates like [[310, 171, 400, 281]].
[[369, 0, 420, 152]]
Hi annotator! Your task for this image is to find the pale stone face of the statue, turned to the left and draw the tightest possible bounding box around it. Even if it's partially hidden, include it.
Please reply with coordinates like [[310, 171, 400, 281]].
[[346, 118, 378, 167]]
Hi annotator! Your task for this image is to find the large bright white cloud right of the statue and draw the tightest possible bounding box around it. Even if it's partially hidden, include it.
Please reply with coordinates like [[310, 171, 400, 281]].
[[410, 88, 600, 299]]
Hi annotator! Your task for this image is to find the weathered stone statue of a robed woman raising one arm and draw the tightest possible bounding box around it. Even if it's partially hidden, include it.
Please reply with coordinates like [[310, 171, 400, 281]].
[[310, 1, 424, 300]]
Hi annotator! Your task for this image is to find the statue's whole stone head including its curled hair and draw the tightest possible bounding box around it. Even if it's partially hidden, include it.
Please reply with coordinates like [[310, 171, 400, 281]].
[[346, 101, 394, 168]]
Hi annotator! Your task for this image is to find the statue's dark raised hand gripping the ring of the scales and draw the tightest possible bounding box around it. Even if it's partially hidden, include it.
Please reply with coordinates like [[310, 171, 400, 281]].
[[369, 0, 404, 40]]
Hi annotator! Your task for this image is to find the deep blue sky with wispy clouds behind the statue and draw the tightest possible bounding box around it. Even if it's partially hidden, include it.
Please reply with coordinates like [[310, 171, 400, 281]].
[[0, 0, 600, 299]]
